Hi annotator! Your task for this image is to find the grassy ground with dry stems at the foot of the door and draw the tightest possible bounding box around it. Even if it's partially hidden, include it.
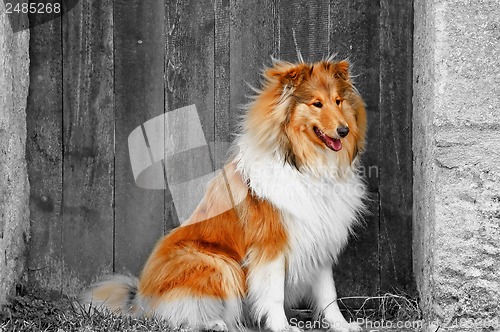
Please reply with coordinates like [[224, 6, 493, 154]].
[[0, 291, 421, 332]]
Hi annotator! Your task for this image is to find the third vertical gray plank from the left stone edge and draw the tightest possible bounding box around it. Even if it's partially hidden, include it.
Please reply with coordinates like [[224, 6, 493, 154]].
[[114, 0, 165, 275]]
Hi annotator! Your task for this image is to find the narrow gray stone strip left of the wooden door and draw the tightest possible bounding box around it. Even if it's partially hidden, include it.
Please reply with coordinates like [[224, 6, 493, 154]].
[[0, 5, 29, 304]]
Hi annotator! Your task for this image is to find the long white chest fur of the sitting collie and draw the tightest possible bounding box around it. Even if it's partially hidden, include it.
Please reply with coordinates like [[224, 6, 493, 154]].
[[239, 152, 365, 288]]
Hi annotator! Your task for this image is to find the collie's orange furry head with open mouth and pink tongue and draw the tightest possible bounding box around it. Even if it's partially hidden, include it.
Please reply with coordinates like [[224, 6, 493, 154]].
[[247, 60, 366, 175]]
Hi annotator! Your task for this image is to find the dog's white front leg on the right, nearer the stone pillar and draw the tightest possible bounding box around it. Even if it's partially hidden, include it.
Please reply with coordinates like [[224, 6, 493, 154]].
[[312, 266, 362, 332]]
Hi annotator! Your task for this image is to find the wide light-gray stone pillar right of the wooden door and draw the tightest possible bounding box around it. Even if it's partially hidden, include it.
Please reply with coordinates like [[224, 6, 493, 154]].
[[413, 0, 500, 331]]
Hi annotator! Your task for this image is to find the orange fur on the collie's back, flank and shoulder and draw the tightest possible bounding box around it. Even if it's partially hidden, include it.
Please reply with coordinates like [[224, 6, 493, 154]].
[[139, 173, 286, 300]]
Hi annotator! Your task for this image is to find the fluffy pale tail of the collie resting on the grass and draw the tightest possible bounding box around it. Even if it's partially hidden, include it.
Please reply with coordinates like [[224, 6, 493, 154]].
[[80, 275, 146, 317]]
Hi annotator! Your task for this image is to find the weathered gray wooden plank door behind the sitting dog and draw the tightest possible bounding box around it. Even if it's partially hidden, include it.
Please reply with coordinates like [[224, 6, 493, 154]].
[[27, 0, 414, 296]]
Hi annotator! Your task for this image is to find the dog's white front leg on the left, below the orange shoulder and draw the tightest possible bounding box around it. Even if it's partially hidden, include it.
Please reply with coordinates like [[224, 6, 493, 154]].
[[247, 255, 293, 332]]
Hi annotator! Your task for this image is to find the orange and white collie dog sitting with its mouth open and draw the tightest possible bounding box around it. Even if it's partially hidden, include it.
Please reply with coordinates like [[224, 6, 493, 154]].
[[84, 58, 366, 332]]
